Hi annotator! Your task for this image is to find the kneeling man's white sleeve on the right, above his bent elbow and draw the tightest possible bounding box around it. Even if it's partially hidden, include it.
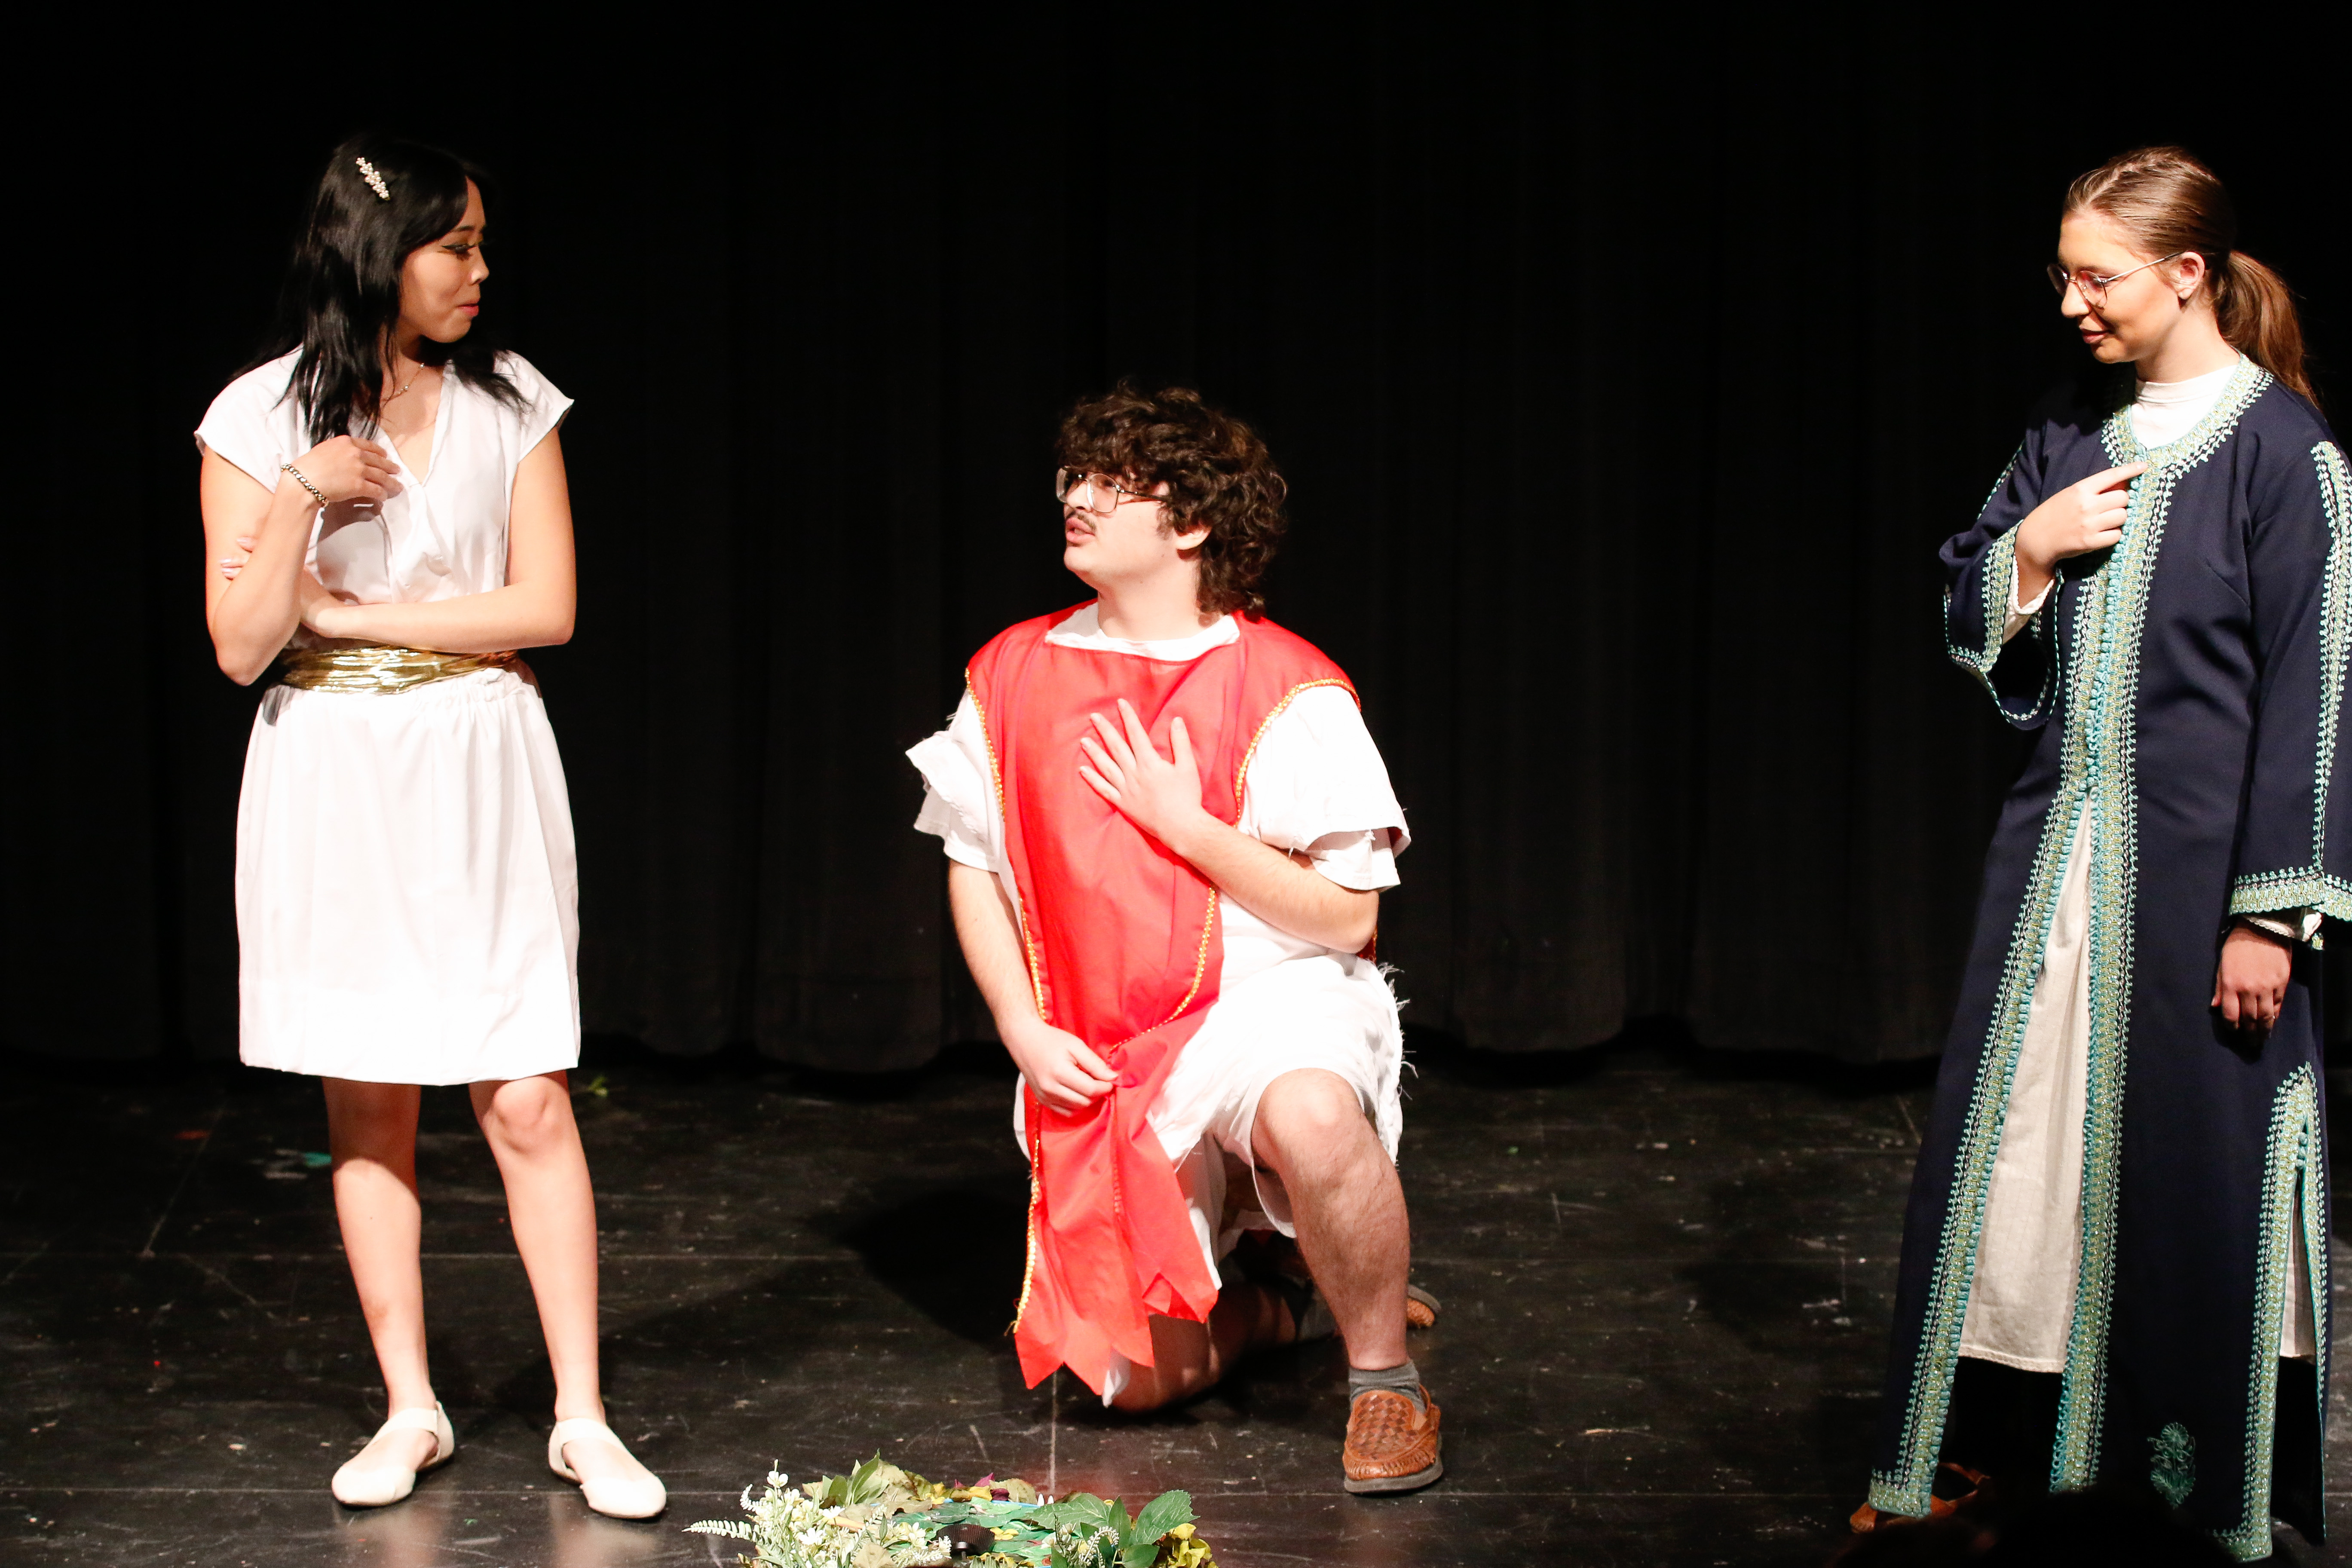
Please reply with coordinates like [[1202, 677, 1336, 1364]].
[[1244, 686, 1409, 851]]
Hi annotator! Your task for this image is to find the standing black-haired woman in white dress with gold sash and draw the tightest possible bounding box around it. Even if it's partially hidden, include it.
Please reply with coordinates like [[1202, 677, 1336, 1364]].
[[198, 136, 666, 1519]]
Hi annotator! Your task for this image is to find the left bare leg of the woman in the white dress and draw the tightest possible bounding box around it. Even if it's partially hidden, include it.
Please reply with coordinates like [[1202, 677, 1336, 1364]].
[[325, 1079, 433, 1469]]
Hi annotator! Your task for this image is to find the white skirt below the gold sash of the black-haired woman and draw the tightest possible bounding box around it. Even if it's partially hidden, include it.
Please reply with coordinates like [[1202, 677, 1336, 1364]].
[[238, 670, 581, 1084]]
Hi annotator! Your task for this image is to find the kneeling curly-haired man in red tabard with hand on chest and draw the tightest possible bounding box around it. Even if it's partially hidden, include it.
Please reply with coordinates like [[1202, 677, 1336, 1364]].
[[908, 386, 1442, 1493]]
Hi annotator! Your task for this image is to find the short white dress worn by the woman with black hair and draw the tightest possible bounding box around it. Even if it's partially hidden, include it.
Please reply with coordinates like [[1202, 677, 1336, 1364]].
[[195, 355, 579, 1084]]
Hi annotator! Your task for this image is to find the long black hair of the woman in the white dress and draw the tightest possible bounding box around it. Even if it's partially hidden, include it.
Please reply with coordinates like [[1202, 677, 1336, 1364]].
[[254, 132, 522, 442]]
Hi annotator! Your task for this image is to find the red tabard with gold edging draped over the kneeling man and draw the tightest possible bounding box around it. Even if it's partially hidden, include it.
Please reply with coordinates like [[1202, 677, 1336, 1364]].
[[965, 606, 1355, 1392]]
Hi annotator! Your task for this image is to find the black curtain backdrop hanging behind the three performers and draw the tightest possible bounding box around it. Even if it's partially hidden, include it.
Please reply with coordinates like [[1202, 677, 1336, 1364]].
[[0, 7, 2352, 1070]]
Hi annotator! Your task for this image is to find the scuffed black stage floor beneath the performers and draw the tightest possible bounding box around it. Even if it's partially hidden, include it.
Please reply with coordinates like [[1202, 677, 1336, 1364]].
[[0, 1046, 2352, 1568]]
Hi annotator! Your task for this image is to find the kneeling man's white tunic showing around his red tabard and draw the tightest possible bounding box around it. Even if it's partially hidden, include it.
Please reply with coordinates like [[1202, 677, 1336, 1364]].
[[908, 604, 1409, 1277]]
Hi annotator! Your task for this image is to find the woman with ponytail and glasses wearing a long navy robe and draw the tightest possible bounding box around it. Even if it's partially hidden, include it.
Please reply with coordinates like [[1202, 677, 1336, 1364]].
[[1853, 148, 2352, 1561]]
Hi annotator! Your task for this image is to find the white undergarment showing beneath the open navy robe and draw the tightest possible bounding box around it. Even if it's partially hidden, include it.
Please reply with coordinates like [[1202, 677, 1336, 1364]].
[[1959, 364, 2317, 1373]]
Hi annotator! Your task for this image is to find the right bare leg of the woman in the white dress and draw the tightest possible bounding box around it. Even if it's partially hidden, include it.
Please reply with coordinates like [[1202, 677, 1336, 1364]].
[[473, 1072, 628, 1479]]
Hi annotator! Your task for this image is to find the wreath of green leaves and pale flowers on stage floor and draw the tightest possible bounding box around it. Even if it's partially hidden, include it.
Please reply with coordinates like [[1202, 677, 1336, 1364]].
[[687, 1453, 1216, 1568]]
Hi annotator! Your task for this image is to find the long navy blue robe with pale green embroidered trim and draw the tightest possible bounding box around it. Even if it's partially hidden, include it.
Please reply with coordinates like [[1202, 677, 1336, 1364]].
[[1870, 360, 2352, 1561]]
